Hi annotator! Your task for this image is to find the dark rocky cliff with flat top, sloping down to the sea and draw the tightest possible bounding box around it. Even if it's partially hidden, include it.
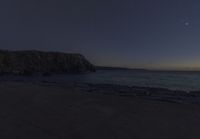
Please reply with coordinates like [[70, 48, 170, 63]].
[[0, 50, 95, 74]]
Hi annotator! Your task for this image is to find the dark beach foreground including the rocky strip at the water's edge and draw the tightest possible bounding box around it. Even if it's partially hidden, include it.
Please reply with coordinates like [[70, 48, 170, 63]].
[[0, 82, 200, 139]]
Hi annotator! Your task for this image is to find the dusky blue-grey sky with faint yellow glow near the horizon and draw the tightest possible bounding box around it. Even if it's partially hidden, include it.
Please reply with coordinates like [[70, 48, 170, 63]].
[[0, 0, 200, 70]]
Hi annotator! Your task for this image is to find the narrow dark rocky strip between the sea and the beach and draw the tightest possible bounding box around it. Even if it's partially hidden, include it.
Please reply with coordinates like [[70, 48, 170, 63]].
[[0, 80, 200, 105]]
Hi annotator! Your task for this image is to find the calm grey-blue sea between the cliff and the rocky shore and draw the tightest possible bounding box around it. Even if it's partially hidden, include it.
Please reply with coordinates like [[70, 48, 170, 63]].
[[0, 70, 200, 91]]
